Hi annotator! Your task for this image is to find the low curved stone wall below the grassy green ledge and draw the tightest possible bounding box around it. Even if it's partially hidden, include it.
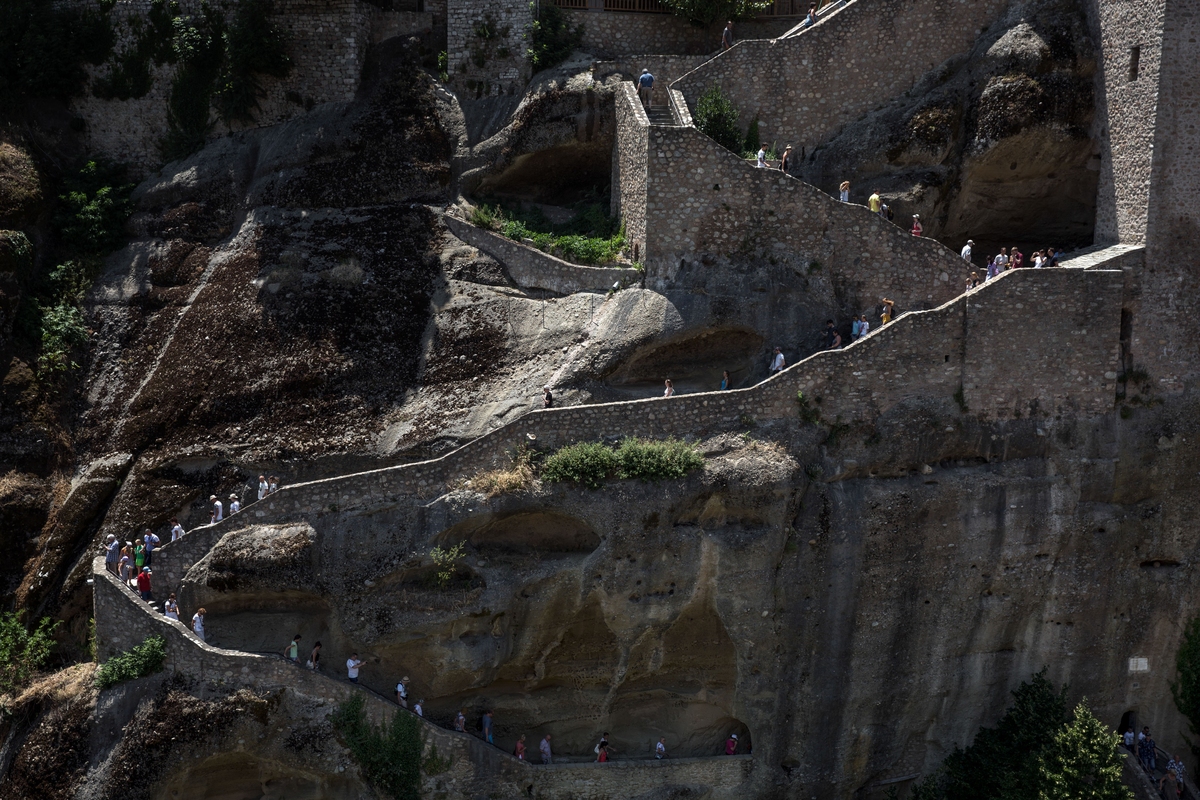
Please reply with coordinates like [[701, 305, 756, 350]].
[[443, 215, 641, 295]]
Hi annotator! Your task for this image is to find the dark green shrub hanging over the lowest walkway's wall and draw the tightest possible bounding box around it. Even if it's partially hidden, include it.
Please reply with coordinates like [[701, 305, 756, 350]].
[[332, 693, 424, 800]]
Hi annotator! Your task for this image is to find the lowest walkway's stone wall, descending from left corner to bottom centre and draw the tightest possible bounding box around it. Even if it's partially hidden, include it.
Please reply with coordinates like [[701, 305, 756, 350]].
[[92, 558, 755, 800]]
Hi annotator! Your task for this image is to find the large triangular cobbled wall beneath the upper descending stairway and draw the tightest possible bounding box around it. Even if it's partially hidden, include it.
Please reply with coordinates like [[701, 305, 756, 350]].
[[638, 112, 964, 311]]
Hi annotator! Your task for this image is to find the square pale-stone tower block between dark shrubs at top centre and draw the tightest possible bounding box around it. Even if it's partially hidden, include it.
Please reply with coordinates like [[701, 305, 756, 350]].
[[446, 0, 533, 98]]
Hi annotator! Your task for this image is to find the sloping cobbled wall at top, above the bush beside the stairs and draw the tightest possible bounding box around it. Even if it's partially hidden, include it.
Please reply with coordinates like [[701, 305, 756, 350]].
[[676, 0, 1008, 152]]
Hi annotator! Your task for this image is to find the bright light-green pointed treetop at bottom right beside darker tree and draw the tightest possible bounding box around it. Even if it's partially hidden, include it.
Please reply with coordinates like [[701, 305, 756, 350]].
[[1037, 699, 1133, 800]]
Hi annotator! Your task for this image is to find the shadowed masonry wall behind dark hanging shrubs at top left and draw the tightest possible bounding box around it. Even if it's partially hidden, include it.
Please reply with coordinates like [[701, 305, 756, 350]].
[[71, 0, 430, 176]]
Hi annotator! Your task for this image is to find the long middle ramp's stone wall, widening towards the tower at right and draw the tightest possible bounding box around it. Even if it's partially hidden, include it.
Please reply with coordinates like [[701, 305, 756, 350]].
[[155, 269, 1124, 563]]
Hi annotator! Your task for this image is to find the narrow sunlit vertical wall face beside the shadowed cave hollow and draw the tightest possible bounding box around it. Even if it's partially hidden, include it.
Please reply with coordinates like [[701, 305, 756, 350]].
[[612, 82, 650, 259]]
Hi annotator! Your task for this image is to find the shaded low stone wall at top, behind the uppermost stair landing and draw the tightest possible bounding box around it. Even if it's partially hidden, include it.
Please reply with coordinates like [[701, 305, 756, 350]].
[[564, 8, 802, 59]]
